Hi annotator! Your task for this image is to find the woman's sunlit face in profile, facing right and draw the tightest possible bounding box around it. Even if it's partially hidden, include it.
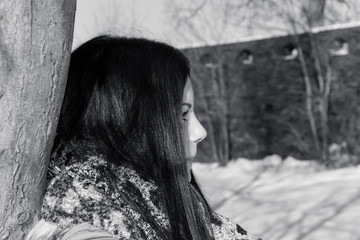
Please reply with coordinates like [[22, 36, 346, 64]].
[[181, 79, 207, 181]]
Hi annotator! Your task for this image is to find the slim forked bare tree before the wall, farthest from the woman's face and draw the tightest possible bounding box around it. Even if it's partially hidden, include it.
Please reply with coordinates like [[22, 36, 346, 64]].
[[255, 0, 331, 162]]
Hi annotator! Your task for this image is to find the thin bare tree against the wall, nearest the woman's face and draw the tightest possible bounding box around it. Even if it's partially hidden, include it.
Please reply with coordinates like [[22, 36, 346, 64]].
[[167, 0, 240, 166]]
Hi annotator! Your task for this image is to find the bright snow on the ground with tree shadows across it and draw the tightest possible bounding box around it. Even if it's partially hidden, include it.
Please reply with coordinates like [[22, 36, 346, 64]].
[[193, 155, 360, 240]]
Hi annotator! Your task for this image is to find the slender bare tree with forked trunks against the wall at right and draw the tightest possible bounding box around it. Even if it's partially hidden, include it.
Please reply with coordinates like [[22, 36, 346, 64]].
[[243, 0, 344, 165]]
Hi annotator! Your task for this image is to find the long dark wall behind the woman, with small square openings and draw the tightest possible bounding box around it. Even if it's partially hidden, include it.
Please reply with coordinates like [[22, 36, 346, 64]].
[[183, 24, 360, 162]]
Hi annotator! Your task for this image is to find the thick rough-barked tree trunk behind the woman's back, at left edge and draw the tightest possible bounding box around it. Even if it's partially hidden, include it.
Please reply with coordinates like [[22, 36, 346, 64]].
[[0, 0, 76, 239]]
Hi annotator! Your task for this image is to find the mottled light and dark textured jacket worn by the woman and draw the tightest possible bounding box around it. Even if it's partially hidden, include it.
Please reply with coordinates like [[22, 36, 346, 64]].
[[42, 145, 258, 240]]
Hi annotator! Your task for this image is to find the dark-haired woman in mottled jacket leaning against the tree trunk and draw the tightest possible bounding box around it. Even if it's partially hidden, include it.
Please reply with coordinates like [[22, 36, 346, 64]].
[[43, 36, 262, 240]]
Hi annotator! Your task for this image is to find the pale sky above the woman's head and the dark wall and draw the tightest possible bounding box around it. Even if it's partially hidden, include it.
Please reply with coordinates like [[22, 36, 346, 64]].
[[73, 0, 360, 49]]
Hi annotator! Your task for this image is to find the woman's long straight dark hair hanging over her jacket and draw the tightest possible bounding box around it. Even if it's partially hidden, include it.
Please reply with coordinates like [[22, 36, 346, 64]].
[[57, 36, 213, 240]]
